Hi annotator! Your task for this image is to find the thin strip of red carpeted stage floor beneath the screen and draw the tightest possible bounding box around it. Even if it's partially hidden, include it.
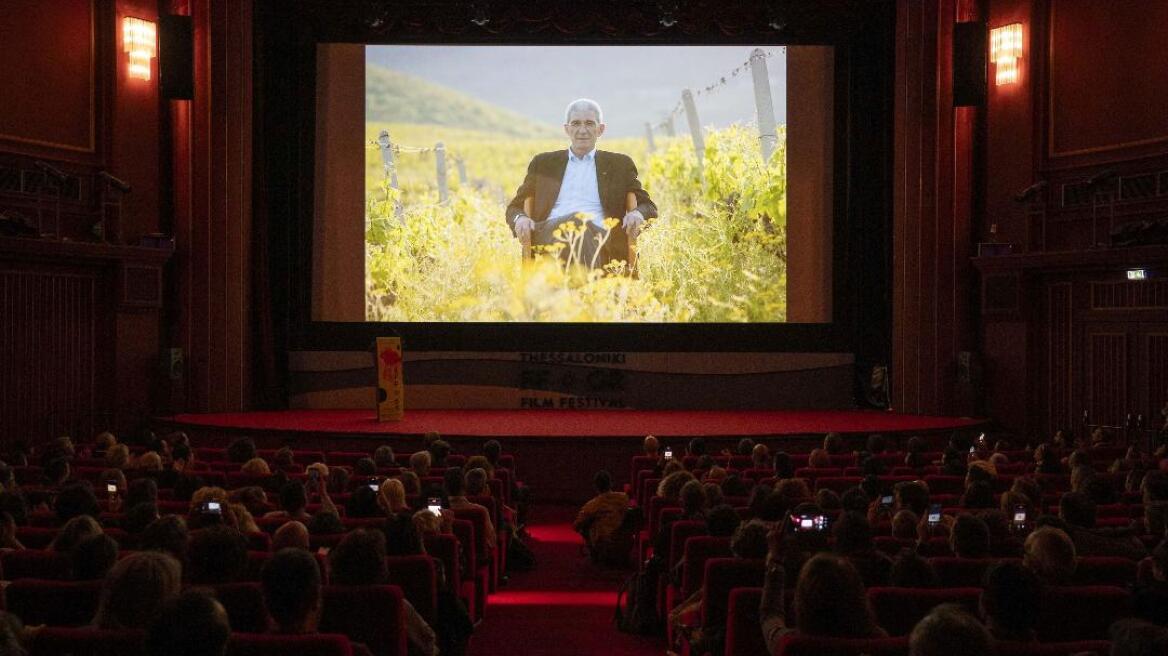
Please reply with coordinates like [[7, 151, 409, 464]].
[[166, 410, 985, 438]]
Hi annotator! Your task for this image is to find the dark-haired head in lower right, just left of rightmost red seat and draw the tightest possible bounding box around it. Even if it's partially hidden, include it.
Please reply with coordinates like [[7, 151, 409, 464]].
[[981, 561, 1042, 641]]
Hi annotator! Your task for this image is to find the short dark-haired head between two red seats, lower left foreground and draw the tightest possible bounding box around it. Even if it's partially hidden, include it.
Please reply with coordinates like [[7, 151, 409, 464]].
[[259, 549, 320, 634]]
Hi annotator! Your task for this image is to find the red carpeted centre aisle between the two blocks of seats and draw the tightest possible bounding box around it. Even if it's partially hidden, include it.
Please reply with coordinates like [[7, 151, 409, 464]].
[[471, 507, 666, 656]]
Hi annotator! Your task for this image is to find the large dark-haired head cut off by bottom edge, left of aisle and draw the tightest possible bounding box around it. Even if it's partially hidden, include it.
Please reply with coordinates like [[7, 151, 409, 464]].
[[146, 589, 231, 656]]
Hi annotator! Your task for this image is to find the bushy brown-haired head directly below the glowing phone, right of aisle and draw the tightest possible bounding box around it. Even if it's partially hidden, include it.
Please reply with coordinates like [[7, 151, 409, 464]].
[[794, 553, 876, 637]]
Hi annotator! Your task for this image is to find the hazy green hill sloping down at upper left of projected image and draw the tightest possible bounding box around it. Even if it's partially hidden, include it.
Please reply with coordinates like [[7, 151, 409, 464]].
[[366, 64, 563, 138]]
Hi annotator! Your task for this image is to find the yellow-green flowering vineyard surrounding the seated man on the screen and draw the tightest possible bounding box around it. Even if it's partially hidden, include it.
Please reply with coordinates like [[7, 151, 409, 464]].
[[366, 123, 786, 322]]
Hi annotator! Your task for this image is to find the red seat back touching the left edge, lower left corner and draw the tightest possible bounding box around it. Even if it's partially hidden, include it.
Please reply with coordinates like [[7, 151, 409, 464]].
[[5, 579, 102, 627]]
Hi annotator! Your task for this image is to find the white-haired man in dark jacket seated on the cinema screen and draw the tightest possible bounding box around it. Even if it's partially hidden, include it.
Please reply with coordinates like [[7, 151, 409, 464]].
[[507, 98, 656, 268]]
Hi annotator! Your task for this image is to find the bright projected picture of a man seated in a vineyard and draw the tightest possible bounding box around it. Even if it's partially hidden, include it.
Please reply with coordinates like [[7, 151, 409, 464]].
[[364, 46, 787, 323]]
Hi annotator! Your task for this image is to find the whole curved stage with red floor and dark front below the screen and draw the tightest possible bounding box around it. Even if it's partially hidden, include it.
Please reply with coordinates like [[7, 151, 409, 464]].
[[159, 410, 985, 503]]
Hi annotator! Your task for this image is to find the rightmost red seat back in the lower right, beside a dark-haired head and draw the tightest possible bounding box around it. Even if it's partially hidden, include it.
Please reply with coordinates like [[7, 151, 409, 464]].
[[1038, 586, 1132, 642]]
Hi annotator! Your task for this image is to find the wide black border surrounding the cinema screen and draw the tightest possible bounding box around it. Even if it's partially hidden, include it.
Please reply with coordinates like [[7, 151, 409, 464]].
[[256, 0, 895, 354]]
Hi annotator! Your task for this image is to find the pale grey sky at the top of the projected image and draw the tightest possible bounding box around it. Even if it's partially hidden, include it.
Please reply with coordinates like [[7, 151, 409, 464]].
[[366, 46, 786, 137]]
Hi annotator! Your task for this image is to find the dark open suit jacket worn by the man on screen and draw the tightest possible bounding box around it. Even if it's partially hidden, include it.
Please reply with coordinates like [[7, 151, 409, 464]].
[[507, 148, 658, 261]]
